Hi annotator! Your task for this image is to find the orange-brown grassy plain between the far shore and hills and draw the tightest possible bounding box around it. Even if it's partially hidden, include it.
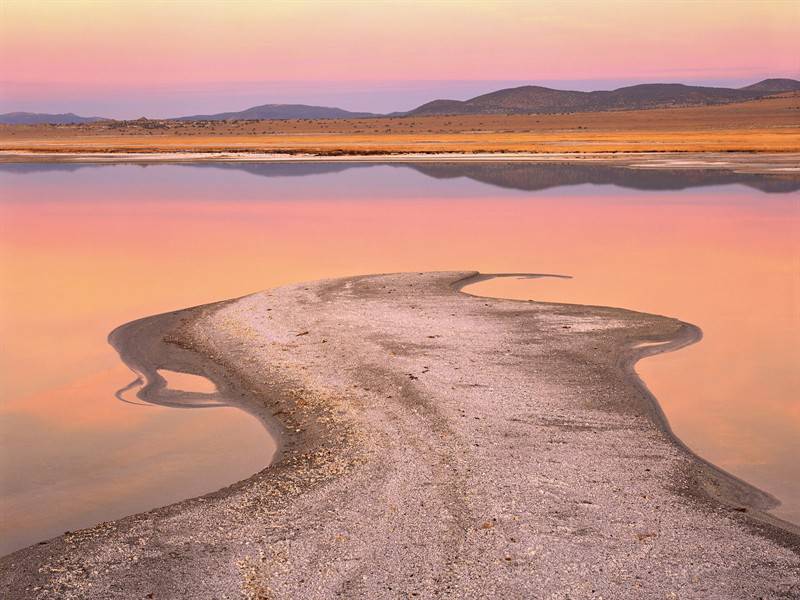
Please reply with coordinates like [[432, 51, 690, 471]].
[[0, 93, 800, 156]]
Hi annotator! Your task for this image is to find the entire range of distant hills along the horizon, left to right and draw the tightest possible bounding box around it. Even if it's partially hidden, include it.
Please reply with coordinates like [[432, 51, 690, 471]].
[[0, 79, 800, 125]]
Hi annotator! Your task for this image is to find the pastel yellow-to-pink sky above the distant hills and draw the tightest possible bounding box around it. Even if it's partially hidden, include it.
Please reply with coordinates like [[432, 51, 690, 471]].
[[0, 0, 800, 118]]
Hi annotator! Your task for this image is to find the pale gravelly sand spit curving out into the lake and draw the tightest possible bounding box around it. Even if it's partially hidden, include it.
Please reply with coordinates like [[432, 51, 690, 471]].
[[0, 272, 800, 599]]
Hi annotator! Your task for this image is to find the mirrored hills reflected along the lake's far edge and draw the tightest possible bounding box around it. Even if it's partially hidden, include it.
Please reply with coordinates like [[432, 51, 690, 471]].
[[0, 161, 800, 193]]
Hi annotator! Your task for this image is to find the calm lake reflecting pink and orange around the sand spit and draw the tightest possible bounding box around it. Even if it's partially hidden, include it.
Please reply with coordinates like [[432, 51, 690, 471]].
[[0, 162, 800, 553]]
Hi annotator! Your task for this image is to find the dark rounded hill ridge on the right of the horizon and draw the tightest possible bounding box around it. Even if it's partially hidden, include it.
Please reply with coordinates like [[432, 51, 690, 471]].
[[407, 79, 800, 116]]
